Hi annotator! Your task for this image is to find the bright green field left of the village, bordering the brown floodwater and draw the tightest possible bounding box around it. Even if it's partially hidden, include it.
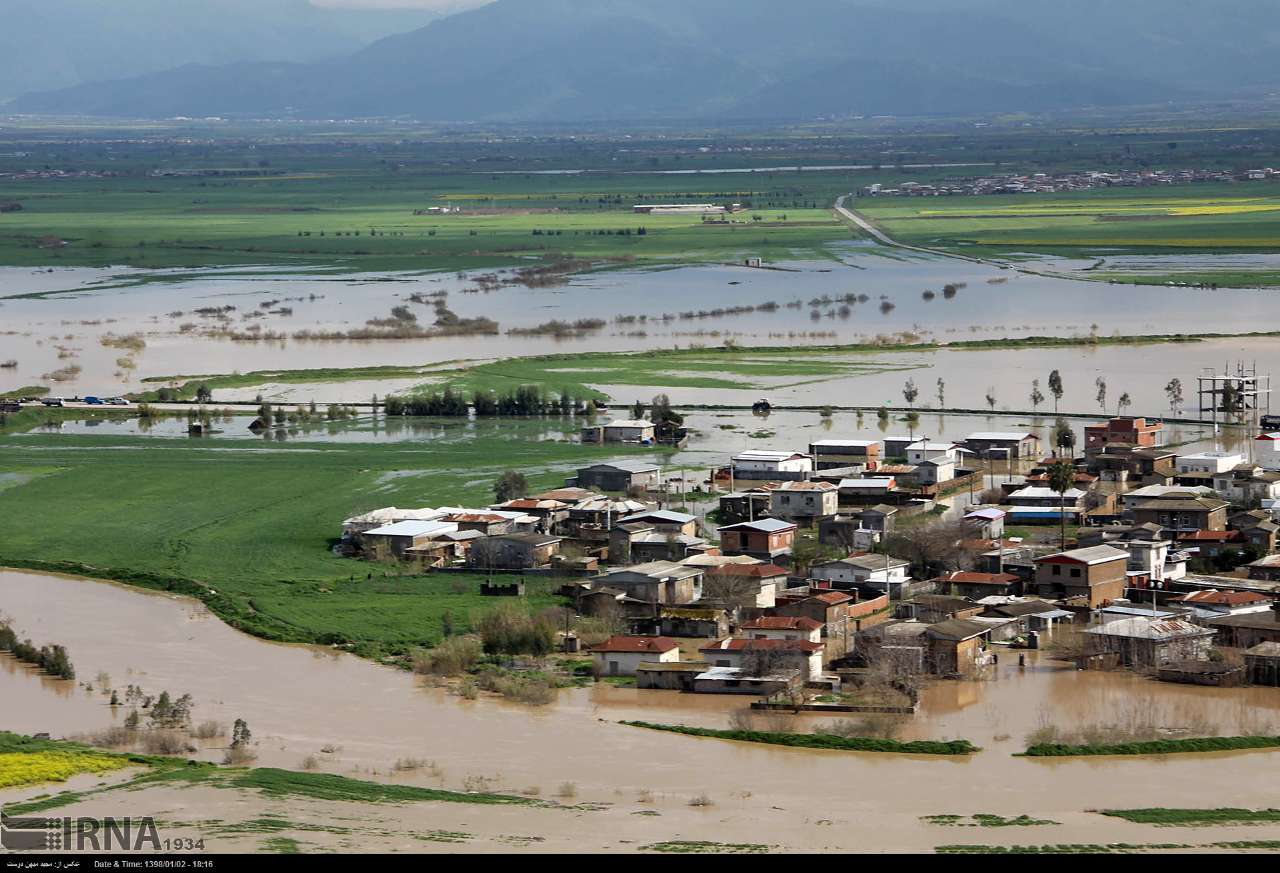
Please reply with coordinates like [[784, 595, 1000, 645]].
[[0, 419, 670, 657]]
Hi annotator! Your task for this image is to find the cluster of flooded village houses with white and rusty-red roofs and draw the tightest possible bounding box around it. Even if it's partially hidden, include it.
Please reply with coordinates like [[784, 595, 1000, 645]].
[[338, 379, 1280, 713]]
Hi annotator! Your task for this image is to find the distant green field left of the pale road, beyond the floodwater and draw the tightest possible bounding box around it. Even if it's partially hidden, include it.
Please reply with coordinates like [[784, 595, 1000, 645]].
[[0, 152, 851, 271]]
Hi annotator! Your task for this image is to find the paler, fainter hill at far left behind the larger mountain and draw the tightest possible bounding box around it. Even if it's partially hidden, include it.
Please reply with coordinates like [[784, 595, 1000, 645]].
[[0, 0, 435, 101]]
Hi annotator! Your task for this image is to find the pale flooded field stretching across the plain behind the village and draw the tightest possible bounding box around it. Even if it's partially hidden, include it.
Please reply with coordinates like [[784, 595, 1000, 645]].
[[0, 243, 1280, 411]]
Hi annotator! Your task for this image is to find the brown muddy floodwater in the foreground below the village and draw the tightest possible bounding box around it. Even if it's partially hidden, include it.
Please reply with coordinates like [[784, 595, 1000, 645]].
[[0, 571, 1280, 850]]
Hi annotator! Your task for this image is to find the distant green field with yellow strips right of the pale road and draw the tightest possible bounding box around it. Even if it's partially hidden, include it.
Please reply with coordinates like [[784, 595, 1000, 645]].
[[851, 183, 1280, 257]]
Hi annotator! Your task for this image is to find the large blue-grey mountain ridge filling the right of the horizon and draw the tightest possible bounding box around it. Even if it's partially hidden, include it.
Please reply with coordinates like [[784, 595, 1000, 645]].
[[12, 0, 1280, 122]]
